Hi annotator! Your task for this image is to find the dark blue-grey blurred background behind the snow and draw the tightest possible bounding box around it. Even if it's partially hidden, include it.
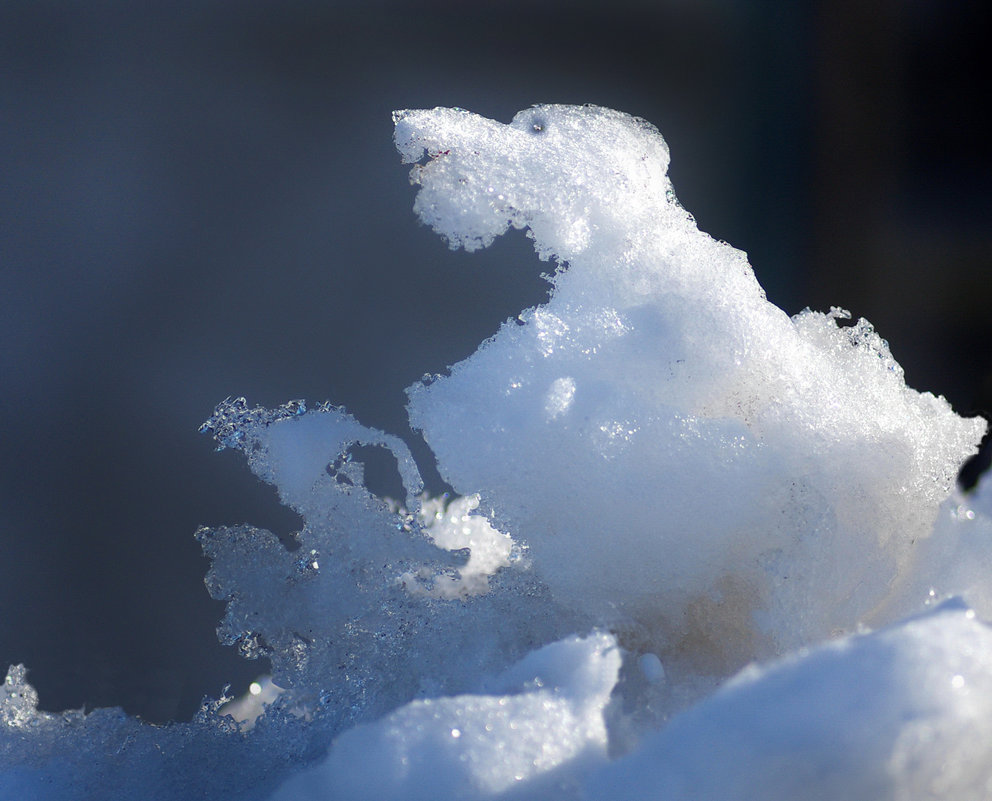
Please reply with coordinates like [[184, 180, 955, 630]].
[[0, 0, 992, 721]]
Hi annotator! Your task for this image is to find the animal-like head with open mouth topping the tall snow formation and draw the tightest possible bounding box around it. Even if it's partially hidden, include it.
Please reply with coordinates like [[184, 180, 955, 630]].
[[393, 105, 673, 261]]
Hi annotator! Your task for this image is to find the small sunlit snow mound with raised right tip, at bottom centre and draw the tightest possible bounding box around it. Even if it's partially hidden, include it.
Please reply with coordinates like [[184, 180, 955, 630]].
[[273, 634, 620, 801]]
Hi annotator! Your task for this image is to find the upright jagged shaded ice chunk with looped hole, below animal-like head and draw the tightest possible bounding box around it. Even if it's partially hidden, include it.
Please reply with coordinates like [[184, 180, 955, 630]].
[[197, 399, 564, 720]]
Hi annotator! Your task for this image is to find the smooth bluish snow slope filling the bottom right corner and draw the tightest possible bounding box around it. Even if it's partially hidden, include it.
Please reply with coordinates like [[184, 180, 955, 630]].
[[583, 603, 992, 801]]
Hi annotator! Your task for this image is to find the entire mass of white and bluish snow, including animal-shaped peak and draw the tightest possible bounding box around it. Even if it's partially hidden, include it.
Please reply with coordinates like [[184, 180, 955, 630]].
[[0, 106, 992, 801]]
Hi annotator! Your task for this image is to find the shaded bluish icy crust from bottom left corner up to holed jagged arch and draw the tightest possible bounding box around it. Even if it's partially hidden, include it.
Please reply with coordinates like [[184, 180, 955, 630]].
[[0, 398, 564, 801]]
